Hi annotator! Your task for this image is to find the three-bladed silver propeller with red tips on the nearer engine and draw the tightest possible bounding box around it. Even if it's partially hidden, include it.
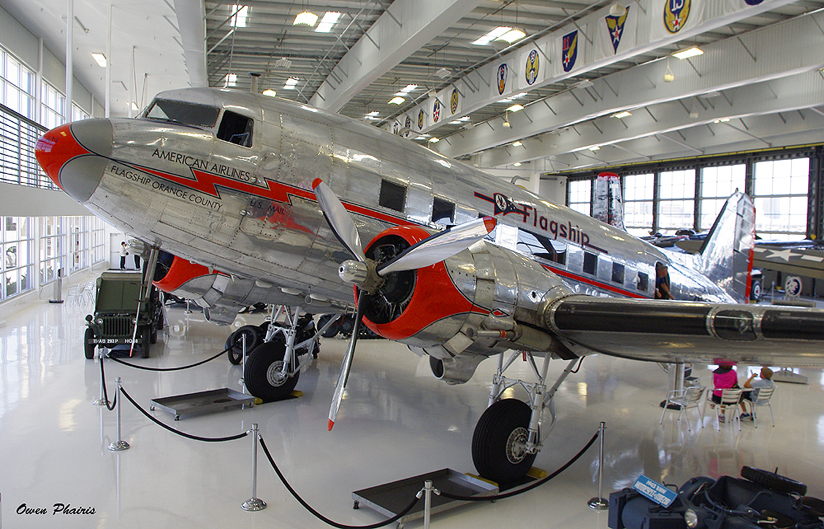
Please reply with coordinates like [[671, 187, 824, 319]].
[[312, 178, 496, 431]]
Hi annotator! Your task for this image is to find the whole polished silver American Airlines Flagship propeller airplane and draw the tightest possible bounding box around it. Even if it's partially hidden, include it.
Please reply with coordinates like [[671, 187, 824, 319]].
[[37, 88, 824, 482]]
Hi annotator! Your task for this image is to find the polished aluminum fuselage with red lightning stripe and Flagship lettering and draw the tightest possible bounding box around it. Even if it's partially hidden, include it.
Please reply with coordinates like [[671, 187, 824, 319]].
[[86, 89, 732, 312]]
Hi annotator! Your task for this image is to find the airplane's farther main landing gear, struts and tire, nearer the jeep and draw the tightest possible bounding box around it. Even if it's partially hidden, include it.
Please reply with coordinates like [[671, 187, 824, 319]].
[[238, 305, 342, 402]]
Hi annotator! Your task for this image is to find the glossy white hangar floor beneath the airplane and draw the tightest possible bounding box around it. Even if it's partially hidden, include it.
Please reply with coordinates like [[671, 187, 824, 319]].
[[0, 278, 824, 528]]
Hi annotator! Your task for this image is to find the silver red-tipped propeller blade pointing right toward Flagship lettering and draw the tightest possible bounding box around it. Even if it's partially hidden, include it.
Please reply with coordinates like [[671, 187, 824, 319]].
[[377, 217, 496, 276]]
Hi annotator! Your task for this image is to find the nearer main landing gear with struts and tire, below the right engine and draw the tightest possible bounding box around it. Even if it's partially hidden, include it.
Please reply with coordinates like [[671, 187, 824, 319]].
[[472, 351, 580, 484]]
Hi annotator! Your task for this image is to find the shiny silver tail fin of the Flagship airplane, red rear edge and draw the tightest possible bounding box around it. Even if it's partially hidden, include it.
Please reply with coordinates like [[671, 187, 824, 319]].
[[699, 190, 755, 303]]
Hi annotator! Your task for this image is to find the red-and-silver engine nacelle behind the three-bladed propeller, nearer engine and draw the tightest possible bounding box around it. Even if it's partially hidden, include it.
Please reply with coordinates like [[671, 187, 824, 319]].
[[364, 226, 572, 368]]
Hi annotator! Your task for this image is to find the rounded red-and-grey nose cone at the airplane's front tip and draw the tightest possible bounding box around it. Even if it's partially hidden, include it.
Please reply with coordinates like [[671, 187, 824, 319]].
[[35, 119, 112, 202]]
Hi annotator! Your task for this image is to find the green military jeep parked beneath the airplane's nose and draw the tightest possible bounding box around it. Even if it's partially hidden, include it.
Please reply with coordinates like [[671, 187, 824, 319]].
[[84, 272, 163, 358]]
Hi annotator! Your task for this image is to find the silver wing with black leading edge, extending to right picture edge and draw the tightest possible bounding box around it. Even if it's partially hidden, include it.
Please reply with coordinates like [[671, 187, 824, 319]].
[[543, 295, 824, 367]]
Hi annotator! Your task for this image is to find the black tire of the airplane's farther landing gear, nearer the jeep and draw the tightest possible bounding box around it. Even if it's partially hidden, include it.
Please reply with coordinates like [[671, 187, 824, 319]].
[[243, 340, 300, 402]]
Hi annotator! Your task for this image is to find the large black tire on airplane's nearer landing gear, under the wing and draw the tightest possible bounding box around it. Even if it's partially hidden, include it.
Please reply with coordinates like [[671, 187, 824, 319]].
[[472, 399, 535, 484]]
